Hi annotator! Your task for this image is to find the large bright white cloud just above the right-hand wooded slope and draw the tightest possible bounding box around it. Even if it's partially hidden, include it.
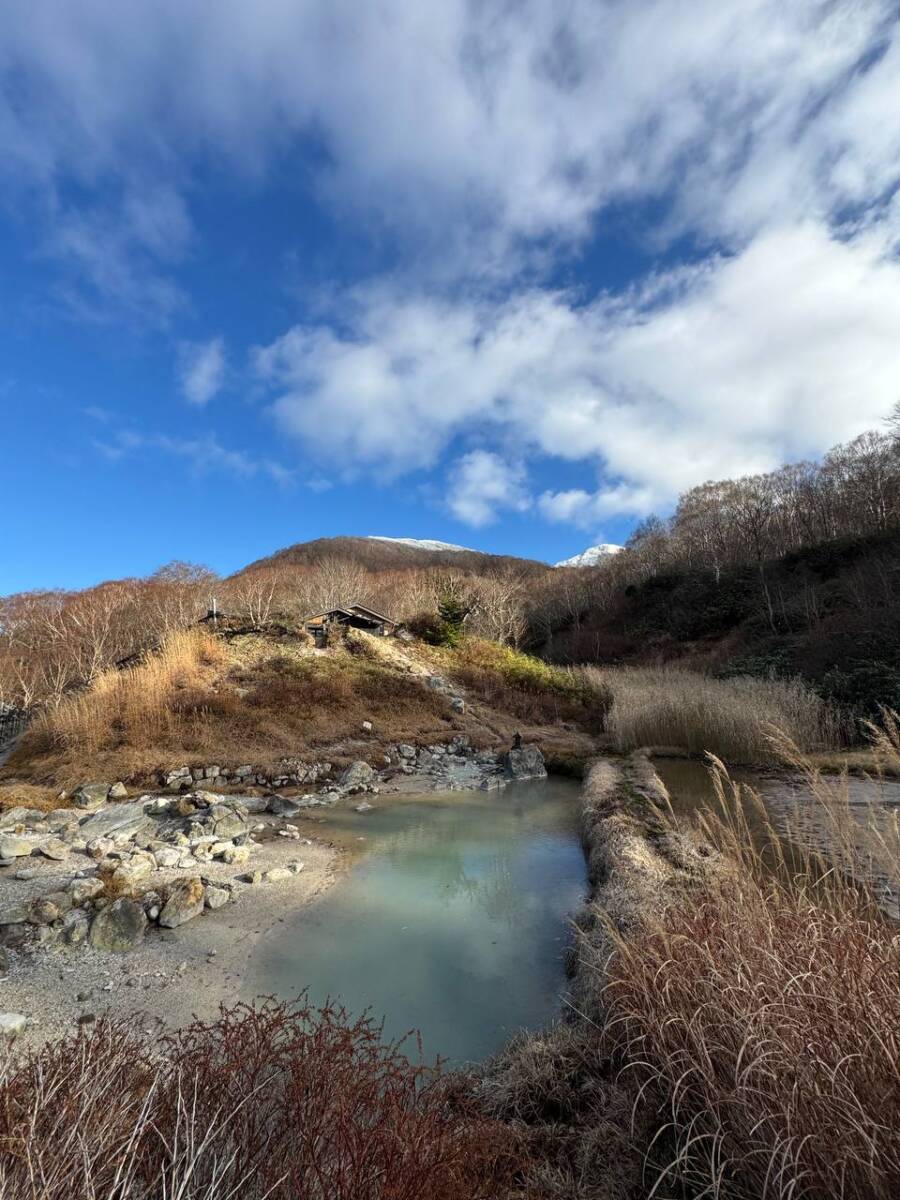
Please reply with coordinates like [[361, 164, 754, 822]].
[[256, 223, 900, 524]]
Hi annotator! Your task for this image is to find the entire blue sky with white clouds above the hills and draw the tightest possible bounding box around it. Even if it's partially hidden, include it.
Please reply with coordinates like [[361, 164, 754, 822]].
[[0, 0, 900, 593]]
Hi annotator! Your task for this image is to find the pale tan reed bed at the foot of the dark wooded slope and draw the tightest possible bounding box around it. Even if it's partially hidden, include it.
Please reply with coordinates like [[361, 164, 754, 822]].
[[581, 667, 844, 763]]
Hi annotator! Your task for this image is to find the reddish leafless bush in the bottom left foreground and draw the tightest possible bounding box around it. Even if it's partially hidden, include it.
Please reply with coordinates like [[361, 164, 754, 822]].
[[0, 998, 516, 1200]]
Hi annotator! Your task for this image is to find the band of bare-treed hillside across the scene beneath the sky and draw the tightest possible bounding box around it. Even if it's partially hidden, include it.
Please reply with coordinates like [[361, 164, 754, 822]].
[[0, 432, 900, 715]]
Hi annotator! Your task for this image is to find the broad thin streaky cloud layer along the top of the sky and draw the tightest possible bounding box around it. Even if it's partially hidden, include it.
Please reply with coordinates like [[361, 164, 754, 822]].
[[0, 0, 900, 277]]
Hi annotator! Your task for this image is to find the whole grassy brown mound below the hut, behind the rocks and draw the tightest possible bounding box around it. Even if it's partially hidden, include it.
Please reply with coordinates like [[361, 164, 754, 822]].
[[0, 626, 604, 804]]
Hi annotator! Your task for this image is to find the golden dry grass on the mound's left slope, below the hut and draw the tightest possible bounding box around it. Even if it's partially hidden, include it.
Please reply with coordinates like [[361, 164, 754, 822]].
[[2, 630, 455, 787]]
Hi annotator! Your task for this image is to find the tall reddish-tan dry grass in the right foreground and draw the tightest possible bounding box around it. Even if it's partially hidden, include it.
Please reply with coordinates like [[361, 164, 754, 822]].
[[598, 715, 900, 1200]]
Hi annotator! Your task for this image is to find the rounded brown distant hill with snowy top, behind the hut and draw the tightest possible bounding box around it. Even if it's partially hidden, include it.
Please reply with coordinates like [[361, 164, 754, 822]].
[[236, 536, 550, 575]]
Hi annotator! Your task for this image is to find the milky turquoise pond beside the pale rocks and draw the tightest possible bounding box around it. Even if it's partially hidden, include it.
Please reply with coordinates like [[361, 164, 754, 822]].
[[248, 779, 586, 1063]]
